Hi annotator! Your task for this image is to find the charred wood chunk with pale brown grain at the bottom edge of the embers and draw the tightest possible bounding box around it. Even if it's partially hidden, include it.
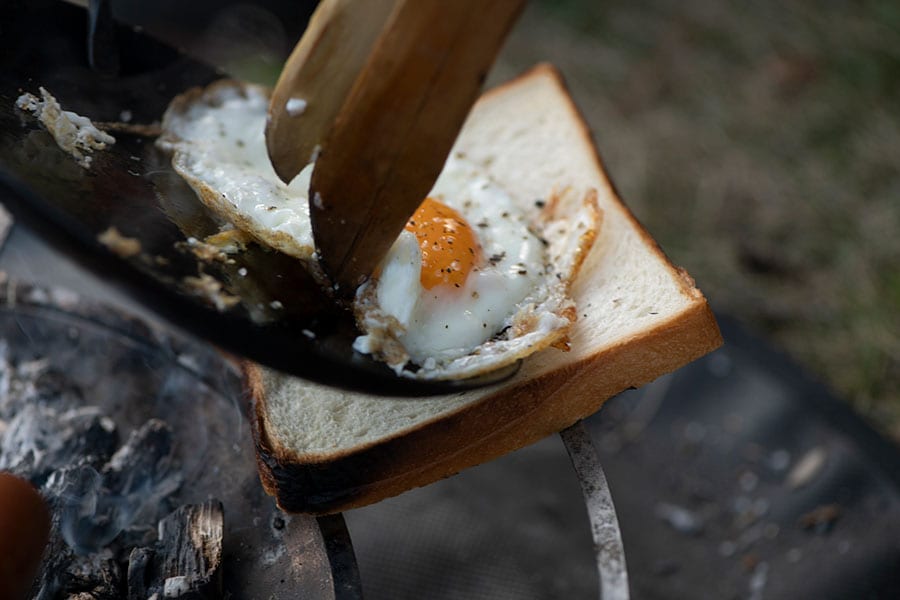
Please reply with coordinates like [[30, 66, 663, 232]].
[[127, 500, 225, 600]]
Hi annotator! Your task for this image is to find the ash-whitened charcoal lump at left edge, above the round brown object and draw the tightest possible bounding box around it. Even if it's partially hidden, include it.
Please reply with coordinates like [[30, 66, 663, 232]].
[[0, 404, 119, 486]]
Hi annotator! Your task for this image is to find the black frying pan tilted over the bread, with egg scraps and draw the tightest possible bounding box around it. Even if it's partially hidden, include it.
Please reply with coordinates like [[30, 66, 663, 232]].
[[0, 0, 514, 395]]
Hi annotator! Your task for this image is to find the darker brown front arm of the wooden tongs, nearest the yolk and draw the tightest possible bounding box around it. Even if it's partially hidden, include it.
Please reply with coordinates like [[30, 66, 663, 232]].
[[310, 0, 524, 289]]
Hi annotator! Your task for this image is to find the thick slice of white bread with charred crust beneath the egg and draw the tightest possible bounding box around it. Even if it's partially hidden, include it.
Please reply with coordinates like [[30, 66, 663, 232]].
[[244, 65, 722, 514]]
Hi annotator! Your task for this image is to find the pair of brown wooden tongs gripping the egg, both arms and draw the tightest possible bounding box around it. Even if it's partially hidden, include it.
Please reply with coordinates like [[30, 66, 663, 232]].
[[266, 0, 524, 293]]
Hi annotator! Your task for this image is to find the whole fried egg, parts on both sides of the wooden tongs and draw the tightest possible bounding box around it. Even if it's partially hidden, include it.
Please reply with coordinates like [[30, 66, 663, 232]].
[[159, 81, 601, 379]]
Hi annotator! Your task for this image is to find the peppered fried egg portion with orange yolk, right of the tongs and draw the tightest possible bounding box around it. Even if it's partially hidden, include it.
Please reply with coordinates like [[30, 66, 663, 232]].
[[354, 154, 600, 379]]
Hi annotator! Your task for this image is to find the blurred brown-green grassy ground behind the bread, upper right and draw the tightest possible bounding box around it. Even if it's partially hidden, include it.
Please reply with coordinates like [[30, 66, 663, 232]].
[[493, 0, 900, 440]]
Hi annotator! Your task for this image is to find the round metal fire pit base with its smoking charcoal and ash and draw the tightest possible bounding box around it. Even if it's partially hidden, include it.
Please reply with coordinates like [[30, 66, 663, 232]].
[[0, 281, 355, 600]]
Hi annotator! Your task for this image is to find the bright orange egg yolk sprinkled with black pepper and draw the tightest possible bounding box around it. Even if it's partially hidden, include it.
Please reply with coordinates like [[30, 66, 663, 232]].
[[406, 197, 481, 290]]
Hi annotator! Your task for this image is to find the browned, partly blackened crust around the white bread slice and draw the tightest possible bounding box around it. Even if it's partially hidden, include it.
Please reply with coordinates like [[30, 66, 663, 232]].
[[243, 64, 722, 514]]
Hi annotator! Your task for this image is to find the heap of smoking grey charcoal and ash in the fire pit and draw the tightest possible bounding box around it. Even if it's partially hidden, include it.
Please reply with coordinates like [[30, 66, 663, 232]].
[[0, 326, 224, 600]]
